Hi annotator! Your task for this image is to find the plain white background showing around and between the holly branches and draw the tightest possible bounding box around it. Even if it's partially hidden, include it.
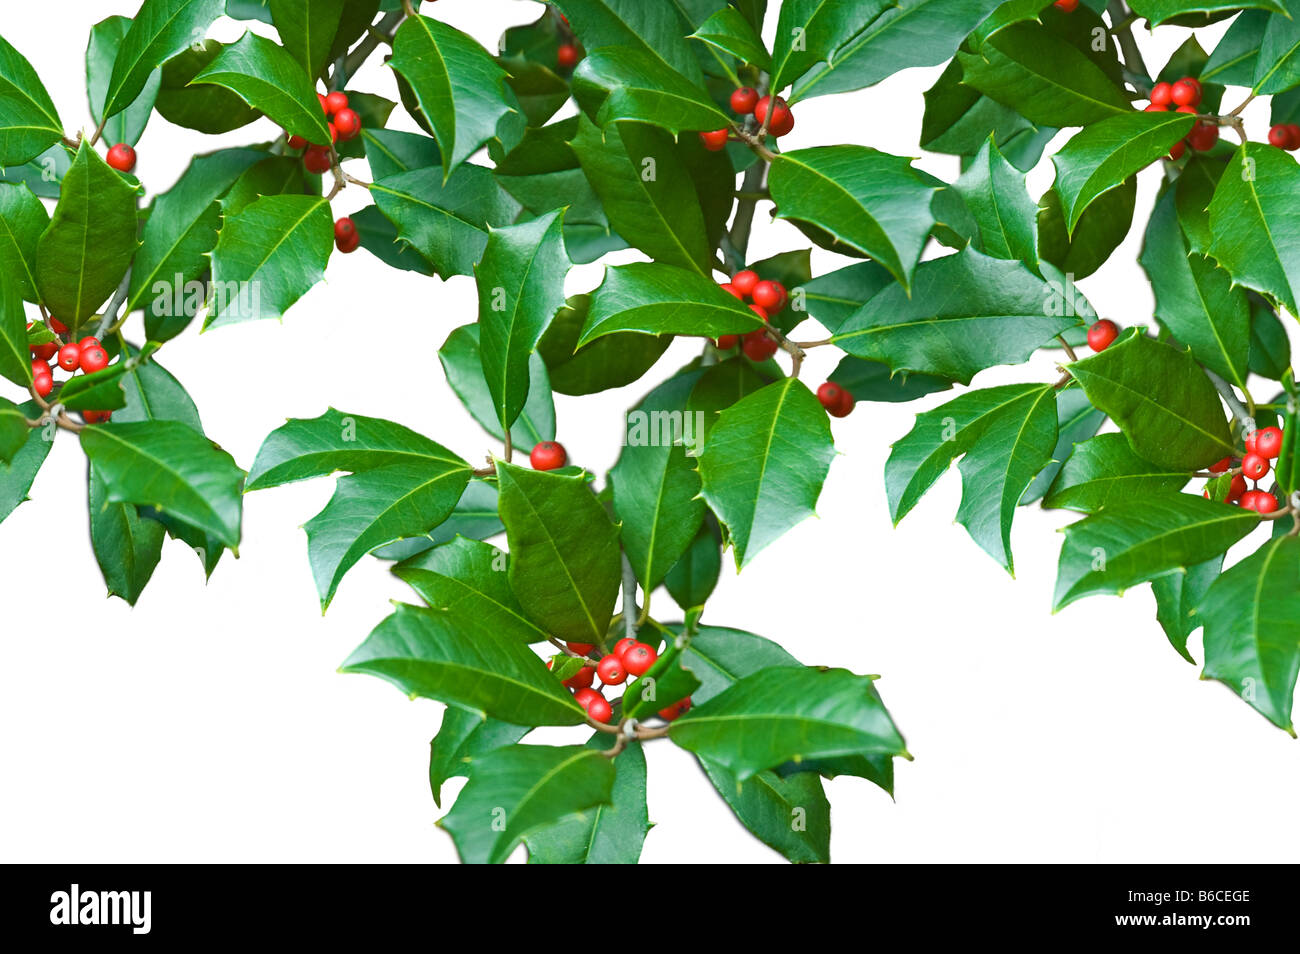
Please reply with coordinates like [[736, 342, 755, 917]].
[[0, 0, 1300, 862]]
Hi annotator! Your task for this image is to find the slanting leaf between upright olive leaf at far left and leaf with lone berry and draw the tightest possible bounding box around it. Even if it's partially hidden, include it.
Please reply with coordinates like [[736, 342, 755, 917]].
[[126, 149, 267, 323]]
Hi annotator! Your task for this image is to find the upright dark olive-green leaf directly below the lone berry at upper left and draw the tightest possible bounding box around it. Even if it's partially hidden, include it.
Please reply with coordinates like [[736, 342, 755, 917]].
[[36, 142, 137, 329]]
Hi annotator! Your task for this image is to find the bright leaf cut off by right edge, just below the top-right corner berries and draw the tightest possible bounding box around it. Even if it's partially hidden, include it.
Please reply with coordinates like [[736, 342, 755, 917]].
[[1209, 143, 1300, 315]]
